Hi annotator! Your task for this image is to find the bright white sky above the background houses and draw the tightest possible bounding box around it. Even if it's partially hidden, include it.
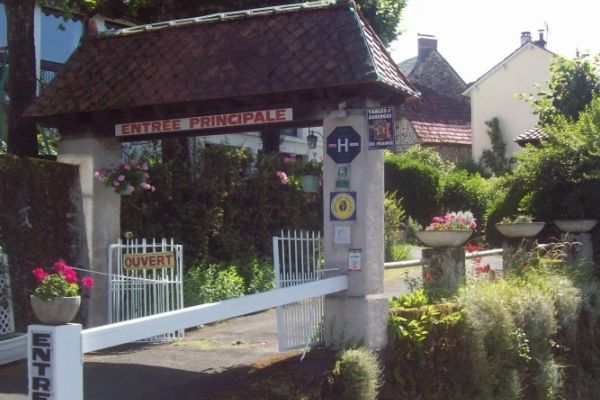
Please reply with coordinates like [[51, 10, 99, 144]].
[[390, 0, 600, 83]]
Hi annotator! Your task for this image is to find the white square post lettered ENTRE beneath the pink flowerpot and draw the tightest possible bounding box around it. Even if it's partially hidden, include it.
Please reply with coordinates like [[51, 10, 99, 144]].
[[27, 324, 83, 400]]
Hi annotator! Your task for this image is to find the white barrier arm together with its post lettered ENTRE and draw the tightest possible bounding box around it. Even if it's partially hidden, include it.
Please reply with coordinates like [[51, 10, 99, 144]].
[[28, 275, 348, 400]]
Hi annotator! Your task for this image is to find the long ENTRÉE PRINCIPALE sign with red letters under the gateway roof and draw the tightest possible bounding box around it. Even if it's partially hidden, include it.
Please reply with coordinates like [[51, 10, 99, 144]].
[[115, 108, 293, 136]]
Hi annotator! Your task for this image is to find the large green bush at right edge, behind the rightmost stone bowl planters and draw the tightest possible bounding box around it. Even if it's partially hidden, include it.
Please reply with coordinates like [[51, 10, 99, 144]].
[[514, 98, 600, 221]]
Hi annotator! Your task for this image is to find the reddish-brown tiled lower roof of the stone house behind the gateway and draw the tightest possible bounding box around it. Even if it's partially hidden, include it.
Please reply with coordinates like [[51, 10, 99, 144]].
[[402, 86, 471, 145]]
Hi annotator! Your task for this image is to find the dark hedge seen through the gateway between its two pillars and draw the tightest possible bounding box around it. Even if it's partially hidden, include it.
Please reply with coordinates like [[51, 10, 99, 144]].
[[121, 145, 323, 266]]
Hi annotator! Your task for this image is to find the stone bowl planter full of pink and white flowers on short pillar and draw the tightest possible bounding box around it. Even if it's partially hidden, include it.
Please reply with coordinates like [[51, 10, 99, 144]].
[[415, 211, 477, 247]]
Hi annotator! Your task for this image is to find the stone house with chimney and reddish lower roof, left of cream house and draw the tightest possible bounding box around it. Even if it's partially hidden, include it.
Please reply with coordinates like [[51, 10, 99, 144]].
[[396, 35, 471, 161]]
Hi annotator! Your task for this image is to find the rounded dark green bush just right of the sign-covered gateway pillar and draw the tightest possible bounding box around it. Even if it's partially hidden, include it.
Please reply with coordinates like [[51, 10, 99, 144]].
[[384, 154, 441, 224]]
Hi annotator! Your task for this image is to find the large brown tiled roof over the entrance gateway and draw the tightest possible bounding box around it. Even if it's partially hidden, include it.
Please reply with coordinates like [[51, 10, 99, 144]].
[[26, 1, 417, 121]]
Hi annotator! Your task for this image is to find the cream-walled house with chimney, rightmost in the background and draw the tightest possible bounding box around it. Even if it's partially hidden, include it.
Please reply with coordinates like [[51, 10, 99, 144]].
[[463, 31, 554, 161]]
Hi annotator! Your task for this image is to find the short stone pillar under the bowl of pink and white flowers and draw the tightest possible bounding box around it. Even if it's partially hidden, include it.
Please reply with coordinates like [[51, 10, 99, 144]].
[[421, 247, 466, 291]]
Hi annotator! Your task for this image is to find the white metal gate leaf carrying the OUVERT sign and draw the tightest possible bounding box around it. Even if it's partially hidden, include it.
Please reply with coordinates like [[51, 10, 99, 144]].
[[108, 239, 184, 342]]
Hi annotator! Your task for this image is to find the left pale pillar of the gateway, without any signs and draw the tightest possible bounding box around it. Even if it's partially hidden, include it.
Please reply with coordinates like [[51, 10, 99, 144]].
[[58, 135, 121, 327]]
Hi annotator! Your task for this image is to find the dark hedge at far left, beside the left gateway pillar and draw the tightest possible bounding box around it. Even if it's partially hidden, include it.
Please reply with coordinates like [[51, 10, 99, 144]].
[[0, 156, 81, 330]]
